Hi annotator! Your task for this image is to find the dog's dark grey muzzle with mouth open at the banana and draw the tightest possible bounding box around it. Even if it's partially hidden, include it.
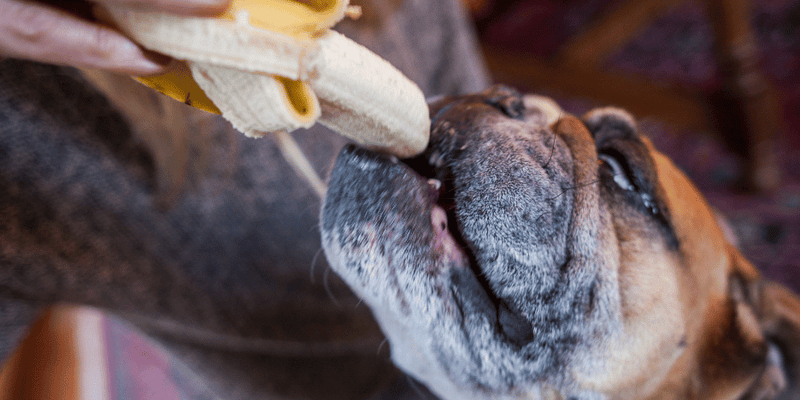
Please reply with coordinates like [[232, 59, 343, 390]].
[[323, 87, 574, 346]]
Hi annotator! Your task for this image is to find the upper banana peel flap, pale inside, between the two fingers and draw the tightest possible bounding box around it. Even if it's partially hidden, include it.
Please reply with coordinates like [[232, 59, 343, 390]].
[[106, 0, 336, 80]]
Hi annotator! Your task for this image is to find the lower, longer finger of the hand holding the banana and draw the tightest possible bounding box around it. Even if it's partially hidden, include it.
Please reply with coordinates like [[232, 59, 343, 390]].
[[0, 0, 168, 75]]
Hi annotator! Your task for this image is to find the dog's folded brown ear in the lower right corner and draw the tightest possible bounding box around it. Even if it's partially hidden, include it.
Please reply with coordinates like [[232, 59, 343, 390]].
[[697, 250, 800, 400]]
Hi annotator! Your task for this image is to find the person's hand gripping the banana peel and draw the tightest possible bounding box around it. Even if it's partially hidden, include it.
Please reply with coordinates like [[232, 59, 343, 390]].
[[0, 0, 230, 75]]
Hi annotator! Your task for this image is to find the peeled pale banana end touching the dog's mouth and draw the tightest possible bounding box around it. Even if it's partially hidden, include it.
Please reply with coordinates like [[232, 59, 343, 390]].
[[311, 31, 430, 157]]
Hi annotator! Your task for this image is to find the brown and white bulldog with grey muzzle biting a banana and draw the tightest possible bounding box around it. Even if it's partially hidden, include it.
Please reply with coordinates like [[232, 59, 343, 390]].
[[321, 86, 800, 399]]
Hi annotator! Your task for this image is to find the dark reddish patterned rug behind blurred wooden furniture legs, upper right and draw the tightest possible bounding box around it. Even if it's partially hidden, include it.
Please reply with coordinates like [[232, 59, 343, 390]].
[[477, 0, 800, 292]]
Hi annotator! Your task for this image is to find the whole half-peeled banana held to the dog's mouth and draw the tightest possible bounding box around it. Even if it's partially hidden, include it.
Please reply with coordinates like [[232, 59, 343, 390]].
[[106, 0, 430, 157]]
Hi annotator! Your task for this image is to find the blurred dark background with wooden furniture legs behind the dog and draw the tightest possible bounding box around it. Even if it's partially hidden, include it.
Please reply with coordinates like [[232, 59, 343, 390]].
[[464, 0, 800, 292]]
